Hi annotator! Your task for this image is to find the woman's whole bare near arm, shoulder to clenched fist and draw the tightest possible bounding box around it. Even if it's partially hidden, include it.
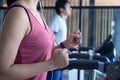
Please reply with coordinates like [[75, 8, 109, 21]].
[[0, 7, 68, 80]]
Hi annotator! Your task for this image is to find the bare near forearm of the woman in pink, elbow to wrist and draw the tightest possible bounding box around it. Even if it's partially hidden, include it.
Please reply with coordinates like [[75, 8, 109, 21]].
[[0, 60, 54, 80]]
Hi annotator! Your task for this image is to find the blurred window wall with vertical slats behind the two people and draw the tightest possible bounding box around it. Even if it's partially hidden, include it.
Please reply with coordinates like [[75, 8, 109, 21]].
[[0, 0, 120, 79]]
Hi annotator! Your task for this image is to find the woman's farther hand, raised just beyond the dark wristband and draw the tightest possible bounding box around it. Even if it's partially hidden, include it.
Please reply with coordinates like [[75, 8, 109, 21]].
[[63, 30, 82, 49]]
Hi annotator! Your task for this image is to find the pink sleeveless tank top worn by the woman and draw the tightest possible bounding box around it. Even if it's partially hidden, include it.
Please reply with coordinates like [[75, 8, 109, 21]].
[[9, 2, 55, 80]]
